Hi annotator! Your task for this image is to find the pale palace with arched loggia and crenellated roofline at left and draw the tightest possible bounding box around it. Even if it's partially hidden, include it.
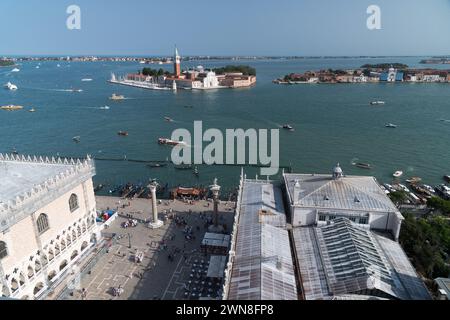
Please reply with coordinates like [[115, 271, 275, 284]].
[[0, 154, 100, 299]]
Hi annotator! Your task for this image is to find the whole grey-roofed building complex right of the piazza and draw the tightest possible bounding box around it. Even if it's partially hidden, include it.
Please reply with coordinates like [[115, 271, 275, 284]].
[[224, 165, 431, 300]]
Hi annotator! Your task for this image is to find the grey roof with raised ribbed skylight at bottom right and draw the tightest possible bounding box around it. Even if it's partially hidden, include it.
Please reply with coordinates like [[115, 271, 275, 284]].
[[293, 218, 430, 300]]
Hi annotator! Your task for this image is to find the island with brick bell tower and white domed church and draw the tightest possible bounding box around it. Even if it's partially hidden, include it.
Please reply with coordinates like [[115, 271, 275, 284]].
[[109, 48, 256, 90]]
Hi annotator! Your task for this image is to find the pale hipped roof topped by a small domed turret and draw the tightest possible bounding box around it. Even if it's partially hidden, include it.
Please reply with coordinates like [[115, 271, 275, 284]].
[[284, 174, 398, 212]]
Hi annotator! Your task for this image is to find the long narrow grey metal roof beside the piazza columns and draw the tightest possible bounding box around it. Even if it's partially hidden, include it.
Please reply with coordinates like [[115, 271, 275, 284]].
[[228, 180, 298, 300]]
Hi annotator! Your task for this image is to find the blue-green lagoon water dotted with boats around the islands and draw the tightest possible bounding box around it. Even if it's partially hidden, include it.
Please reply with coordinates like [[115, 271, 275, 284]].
[[0, 57, 450, 195]]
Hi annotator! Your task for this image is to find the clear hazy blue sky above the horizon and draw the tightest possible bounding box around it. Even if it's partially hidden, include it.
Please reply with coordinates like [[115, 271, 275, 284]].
[[0, 0, 450, 55]]
